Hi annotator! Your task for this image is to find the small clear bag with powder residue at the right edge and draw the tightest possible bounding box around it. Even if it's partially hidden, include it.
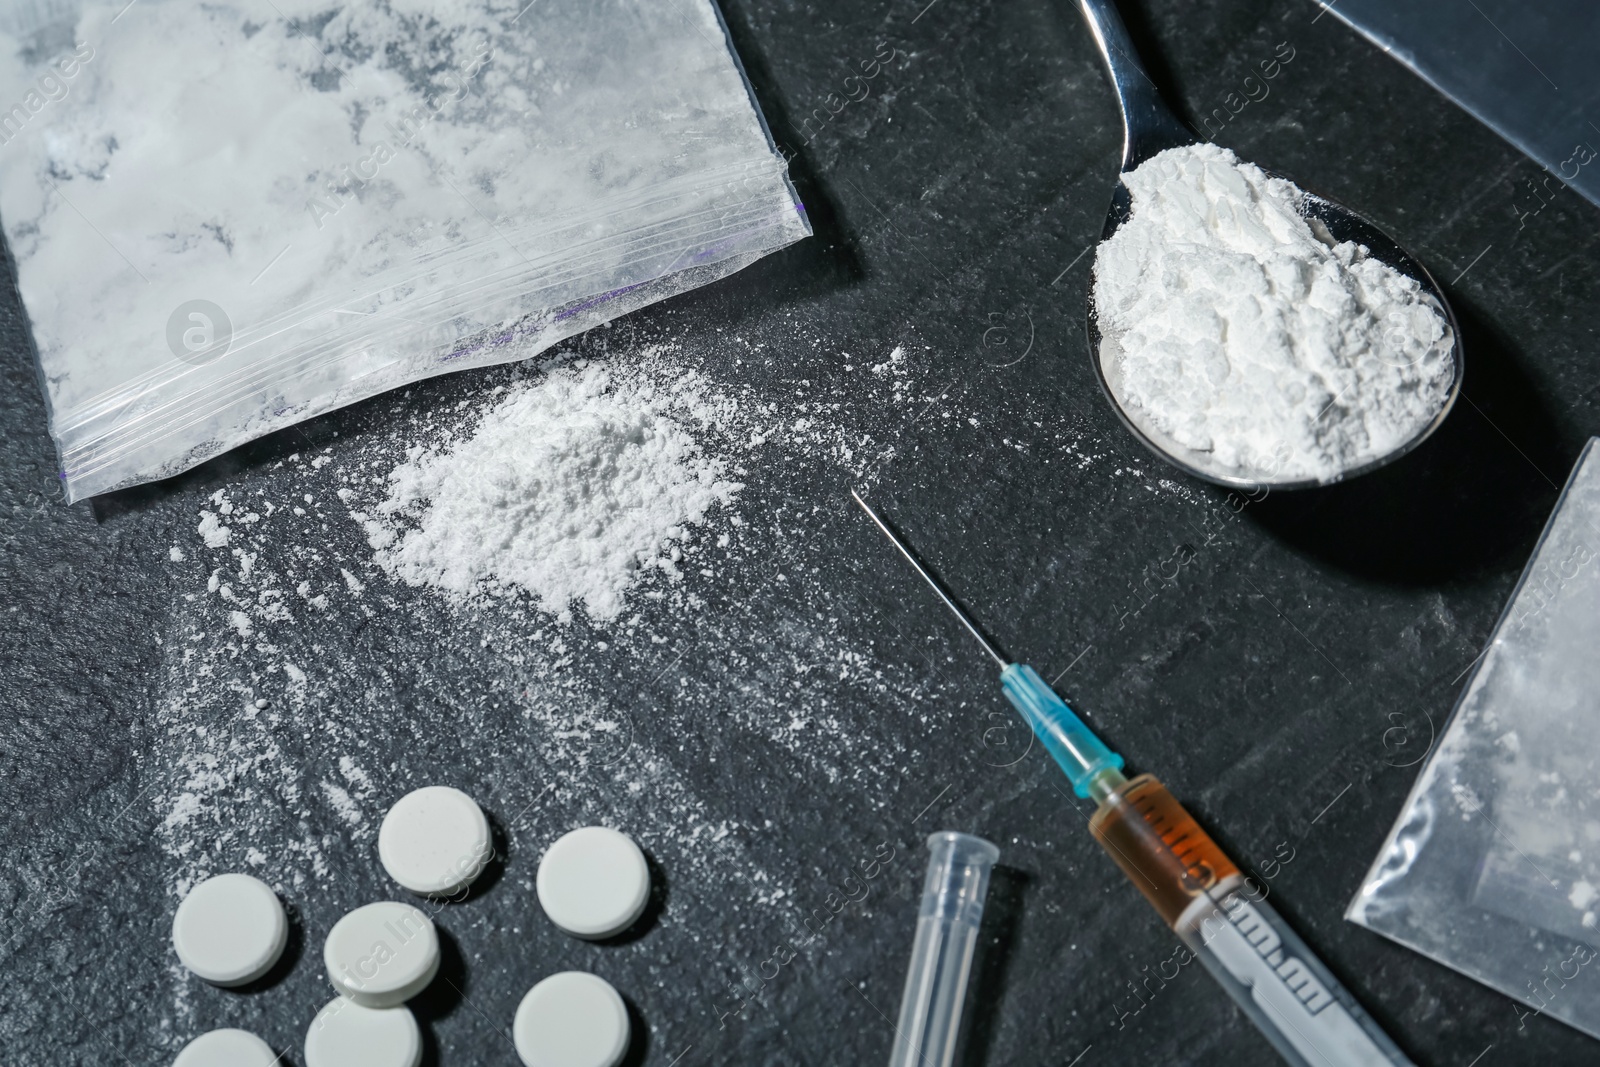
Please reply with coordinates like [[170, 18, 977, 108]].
[[1346, 438, 1600, 1038]]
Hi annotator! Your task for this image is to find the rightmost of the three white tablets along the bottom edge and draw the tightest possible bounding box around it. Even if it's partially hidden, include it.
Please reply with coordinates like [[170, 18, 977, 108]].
[[510, 971, 629, 1067]]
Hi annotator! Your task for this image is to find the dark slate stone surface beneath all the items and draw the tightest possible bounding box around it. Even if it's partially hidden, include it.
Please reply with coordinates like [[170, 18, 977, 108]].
[[0, 0, 1600, 1067]]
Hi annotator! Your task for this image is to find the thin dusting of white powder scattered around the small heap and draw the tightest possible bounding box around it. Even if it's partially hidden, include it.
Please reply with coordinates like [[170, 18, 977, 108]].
[[144, 329, 998, 1033]]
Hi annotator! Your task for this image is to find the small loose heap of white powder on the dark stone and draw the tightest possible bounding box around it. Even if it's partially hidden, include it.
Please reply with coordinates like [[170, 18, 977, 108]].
[[366, 365, 742, 619]]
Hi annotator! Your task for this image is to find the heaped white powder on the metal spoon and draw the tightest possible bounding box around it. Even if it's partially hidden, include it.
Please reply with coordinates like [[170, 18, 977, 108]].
[[1094, 144, 1454, 482]]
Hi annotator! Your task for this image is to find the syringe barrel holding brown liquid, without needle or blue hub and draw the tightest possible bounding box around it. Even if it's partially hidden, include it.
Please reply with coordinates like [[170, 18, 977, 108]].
[[1090, 774, 1411, 1067]]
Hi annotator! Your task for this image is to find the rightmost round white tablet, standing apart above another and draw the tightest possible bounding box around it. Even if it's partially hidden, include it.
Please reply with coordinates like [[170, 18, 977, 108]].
[[538, 825, 650, 937]]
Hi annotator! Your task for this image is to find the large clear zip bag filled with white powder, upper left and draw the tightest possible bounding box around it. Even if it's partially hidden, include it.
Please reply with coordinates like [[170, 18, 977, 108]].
[[0, 0, 810, 499]]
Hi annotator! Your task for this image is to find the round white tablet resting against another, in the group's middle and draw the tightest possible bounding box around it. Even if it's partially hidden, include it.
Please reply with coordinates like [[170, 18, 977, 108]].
[[322, 901, 438, 1008]]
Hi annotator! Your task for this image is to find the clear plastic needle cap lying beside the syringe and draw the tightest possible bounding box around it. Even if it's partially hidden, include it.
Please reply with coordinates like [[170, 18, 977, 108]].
[[890, 830, 1000, 1067]]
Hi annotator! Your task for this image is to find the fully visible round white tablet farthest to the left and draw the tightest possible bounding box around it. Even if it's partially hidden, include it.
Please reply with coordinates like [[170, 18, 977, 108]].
[[173, 875, 290, 985]]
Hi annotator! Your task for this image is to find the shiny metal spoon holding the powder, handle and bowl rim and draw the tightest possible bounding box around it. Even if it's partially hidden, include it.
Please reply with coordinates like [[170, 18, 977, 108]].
[[1078, 0, 1464, 490]]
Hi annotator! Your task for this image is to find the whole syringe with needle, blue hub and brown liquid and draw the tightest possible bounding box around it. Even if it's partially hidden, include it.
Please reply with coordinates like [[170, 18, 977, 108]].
[[851, 491, 1411, 1067]]
